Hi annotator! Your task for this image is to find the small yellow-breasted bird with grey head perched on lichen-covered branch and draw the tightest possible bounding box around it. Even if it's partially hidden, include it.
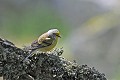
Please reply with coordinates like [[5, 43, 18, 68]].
[[24, 29, 61, 61]]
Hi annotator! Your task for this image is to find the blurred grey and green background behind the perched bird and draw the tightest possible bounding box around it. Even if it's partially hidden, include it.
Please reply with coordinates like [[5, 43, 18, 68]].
[[0, 0, 120, 80]]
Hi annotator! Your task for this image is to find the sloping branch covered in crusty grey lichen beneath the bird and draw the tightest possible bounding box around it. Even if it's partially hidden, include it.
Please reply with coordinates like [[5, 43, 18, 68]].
[[0, 39, 107, 80]]
